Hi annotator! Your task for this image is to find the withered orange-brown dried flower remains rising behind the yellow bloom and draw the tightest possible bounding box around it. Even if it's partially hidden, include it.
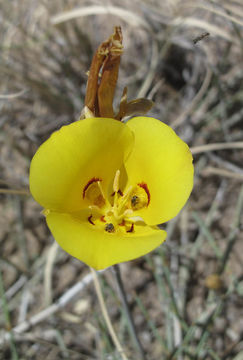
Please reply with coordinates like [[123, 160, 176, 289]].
[[82, 26, 154, 120]]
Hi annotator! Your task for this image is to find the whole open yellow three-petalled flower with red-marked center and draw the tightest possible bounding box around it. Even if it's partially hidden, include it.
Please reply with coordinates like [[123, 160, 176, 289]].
[[30, 117, 193, 270]]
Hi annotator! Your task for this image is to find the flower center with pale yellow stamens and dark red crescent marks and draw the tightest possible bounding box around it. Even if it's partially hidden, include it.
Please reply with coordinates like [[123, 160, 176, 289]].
[[83, 170, 150, 233]]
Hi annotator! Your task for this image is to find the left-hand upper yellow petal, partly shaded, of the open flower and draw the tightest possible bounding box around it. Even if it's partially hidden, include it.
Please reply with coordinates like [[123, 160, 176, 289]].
[[30, 118, 133, 212]]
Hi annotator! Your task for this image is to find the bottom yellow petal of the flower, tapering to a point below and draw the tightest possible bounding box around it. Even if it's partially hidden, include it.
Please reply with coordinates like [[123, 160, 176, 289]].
[[46, 212, 166, 270]]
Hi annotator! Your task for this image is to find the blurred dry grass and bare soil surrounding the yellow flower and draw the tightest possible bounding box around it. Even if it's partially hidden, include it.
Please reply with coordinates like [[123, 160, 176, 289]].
[[0, 0, 243, 360]]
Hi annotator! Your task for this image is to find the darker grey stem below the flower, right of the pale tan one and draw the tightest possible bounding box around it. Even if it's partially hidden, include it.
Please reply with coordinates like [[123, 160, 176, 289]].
[[112, 264, 146, 360]]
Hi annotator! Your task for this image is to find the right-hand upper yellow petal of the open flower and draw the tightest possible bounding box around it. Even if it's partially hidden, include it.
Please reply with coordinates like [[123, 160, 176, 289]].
[[125, 117, 193, 224]]
